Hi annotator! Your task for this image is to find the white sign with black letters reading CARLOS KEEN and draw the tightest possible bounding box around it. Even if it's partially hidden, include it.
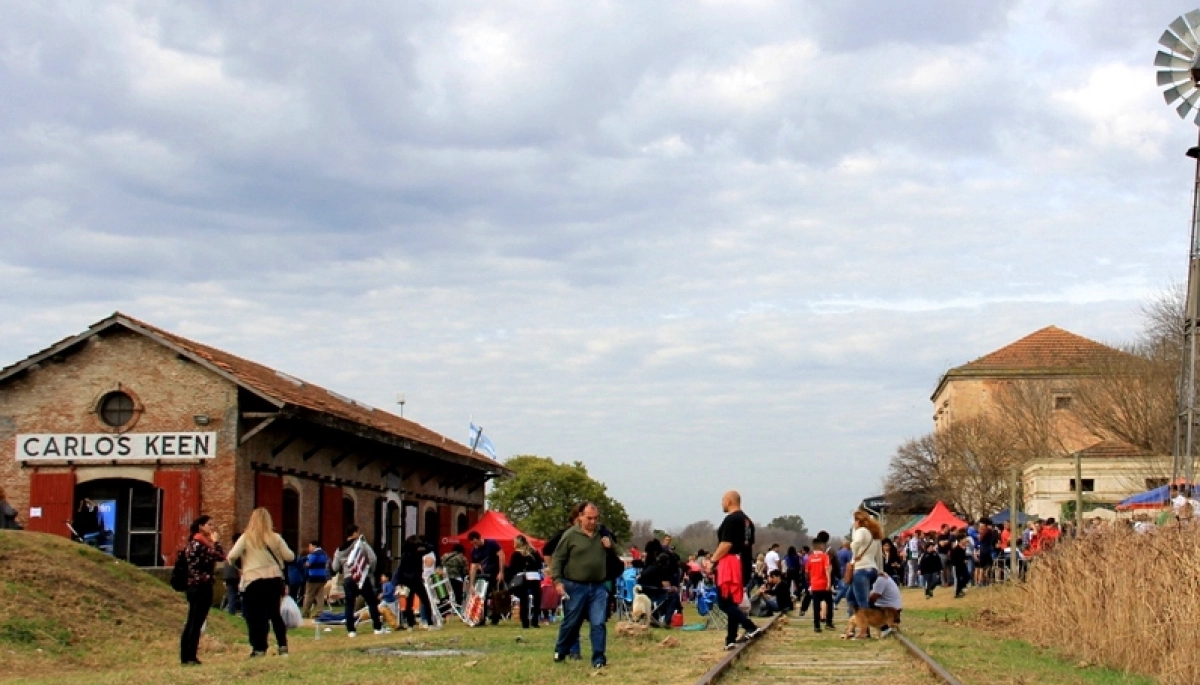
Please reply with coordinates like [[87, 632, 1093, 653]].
[[17, 433, 217, 462]]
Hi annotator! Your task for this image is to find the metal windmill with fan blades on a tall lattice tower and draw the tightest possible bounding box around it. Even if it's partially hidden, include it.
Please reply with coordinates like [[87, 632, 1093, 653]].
[[1154, 10, 1200, 494]]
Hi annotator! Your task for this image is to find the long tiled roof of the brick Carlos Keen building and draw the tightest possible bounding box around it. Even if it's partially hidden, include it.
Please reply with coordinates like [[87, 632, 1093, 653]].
[[0, 312, 506, 471]]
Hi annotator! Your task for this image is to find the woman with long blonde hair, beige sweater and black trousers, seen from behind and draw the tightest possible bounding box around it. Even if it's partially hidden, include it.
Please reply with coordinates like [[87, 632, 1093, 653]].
[[227, 507, 295, 657]]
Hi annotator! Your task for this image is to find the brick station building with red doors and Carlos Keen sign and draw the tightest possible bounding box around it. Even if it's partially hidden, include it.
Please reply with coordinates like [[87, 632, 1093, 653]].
[[0, 313, 505, 566]]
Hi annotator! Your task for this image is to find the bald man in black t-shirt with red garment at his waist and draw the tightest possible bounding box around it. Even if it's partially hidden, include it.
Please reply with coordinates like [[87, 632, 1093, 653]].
[[707, 489, 762, 649]]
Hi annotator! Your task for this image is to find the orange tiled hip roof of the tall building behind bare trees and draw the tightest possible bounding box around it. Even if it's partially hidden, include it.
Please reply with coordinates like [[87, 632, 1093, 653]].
[[950, 326, 1126, 372]]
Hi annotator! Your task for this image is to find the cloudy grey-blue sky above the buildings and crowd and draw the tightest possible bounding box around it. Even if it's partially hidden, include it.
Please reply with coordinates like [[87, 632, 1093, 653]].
[[0, 0, 1196, 530]]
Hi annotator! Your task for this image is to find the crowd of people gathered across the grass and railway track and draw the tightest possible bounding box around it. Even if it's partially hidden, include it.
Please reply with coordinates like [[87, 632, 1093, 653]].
[[166, 491, 1142, 668]]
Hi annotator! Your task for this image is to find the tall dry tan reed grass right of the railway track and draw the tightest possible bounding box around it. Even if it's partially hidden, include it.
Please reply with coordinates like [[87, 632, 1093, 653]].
[[1013, 525, 1200, 685]]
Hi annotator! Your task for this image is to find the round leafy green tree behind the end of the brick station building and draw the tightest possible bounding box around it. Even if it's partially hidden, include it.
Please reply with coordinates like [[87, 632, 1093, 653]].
[[487, 455, 632, 542]]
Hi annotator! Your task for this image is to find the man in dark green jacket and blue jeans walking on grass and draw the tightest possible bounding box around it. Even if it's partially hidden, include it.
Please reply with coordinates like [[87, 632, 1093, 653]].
[[550, 503, 612, 668]]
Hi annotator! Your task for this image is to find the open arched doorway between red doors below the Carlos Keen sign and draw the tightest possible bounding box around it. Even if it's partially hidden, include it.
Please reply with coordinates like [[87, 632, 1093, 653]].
[[72, 479, 159, 566]]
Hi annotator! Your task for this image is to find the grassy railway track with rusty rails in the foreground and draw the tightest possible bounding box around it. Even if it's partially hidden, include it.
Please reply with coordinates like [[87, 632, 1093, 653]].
[[696, 617, 960, 685]]
